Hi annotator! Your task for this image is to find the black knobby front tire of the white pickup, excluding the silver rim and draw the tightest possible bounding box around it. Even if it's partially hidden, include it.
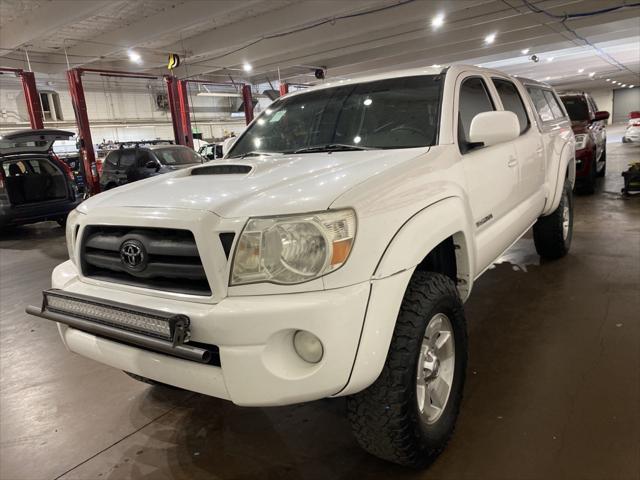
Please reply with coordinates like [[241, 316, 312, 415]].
[[347, 271, 467, 468]]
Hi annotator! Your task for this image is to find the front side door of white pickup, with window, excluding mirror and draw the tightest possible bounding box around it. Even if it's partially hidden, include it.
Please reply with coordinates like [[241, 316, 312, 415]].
[[456, 74, 518, 272]]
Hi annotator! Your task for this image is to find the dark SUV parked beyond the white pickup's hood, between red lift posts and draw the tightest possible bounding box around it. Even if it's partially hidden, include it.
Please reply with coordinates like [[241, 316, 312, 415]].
[[100, 145, 203, 190]]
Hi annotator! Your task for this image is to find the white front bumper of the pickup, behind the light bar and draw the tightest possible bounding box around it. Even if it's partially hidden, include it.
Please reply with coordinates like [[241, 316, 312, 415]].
[[47, 261, 372, 406]]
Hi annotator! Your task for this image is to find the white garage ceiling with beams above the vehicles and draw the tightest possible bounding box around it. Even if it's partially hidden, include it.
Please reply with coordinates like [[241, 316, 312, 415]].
[[0, 0, 640, 88]]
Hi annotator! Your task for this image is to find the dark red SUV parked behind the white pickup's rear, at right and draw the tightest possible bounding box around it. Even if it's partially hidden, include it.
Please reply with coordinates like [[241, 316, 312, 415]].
[[560, 93, 609, 193]]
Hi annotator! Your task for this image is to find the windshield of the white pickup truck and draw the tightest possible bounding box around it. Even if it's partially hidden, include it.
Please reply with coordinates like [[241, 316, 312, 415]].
[[229, 75, 443, 157]]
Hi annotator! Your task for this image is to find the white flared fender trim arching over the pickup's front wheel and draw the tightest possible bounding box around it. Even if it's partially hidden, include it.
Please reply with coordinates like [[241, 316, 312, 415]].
[[337, 197, 475, 396]]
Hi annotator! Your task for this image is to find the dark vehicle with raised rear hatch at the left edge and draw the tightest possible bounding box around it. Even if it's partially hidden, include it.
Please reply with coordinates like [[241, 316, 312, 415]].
[[0, 129, 81, 227]]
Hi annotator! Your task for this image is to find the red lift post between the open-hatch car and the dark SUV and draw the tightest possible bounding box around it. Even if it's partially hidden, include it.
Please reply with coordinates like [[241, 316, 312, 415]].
[[67, 68, 100, 195]]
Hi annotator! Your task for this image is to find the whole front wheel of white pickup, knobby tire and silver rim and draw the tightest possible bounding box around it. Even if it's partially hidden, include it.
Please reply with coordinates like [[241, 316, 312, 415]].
[[347, 272, 467, 468]]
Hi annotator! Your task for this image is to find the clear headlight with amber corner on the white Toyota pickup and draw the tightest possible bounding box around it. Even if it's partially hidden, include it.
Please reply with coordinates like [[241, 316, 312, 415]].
[[231, 209, 356, 286]]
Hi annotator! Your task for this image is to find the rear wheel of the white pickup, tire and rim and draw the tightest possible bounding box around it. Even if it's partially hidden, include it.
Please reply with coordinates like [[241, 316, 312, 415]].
[[533, 180, 573, 260]]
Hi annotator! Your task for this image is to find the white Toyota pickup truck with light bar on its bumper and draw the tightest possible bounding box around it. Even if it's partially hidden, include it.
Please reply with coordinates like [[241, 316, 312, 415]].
[[27, 65, 575, 467]]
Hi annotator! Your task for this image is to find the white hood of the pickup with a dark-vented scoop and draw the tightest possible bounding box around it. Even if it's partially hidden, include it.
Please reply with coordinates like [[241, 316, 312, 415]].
[[79, 147, 429, 218]]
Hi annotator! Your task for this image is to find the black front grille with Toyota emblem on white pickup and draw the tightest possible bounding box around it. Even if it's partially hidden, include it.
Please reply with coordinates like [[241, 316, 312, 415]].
[[80, 225, 211, 296]]
